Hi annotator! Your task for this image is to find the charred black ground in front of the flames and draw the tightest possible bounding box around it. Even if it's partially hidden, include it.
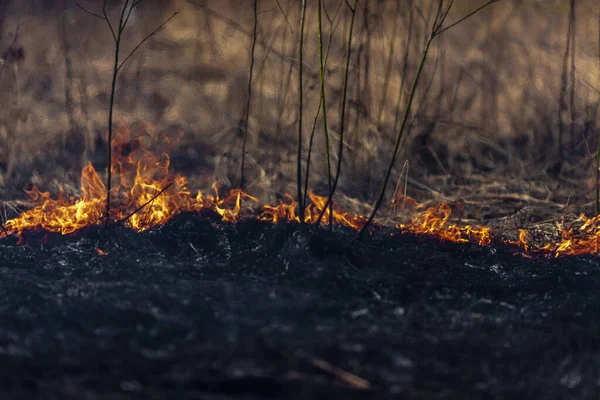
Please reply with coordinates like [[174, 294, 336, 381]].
[[0, 215, 600, 399]]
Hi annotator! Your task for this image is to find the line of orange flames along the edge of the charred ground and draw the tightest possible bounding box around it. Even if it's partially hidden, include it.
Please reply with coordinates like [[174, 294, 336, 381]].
[[0, 126, 600, 257]]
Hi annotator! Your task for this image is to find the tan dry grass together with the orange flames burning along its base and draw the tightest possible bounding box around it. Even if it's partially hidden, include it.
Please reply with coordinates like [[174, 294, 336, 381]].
[[0, 0, 600, 255]]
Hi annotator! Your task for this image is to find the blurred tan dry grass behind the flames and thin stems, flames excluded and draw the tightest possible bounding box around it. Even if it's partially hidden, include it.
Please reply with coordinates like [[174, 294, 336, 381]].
[[0, 0, 600, 220]]
